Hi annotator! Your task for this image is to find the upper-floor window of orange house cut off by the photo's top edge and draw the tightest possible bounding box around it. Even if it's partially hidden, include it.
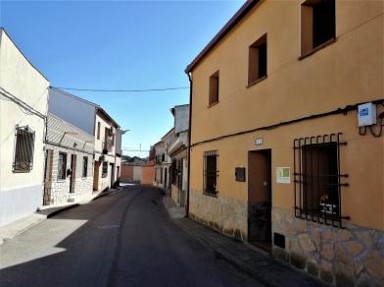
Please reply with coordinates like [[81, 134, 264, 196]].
[[301, 0, 336, 55]]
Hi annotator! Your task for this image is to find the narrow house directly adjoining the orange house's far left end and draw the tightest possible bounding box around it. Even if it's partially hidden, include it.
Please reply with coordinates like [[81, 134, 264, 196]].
[[167, 105, 189, 206]]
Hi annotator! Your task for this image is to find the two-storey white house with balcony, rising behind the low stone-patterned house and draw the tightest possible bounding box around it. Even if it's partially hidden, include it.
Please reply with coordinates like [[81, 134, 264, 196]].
[[48, 88, 122, 191]]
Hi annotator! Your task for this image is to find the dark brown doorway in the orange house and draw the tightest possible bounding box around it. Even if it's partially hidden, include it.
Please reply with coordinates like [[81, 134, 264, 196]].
[[248, 149, 272, 252]]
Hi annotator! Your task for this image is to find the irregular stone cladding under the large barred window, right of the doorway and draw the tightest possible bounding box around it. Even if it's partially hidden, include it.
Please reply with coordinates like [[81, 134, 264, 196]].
[[272, 208, 384, 287]]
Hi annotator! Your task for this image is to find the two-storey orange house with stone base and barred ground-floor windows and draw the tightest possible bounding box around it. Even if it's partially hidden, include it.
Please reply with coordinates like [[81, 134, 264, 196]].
[[186, 0, 384, 286]]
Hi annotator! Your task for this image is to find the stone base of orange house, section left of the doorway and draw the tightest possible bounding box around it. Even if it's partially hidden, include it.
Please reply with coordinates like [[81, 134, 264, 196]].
[[189, 190, 248, 241]]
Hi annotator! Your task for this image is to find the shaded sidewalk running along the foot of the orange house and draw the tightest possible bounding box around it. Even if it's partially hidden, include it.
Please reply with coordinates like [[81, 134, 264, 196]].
[[163, 196, 328, 287]]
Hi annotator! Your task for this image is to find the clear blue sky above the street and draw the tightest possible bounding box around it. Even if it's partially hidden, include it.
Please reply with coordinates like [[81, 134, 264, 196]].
[[0, 0, 244, 157]]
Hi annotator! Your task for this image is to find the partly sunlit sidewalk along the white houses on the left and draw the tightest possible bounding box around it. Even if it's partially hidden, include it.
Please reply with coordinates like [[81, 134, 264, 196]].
[[0, 188, 119, 245]]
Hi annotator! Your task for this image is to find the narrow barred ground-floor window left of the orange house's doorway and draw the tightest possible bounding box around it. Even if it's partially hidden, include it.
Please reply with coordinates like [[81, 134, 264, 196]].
[[204, 151, 218, 195]]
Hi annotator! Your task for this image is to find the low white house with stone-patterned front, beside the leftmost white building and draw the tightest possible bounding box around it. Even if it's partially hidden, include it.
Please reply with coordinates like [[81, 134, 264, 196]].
[[43, 113, 95, 206]]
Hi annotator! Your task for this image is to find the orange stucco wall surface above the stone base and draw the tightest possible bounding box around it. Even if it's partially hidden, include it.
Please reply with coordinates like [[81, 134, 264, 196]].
[[190, 0, 384, 230]]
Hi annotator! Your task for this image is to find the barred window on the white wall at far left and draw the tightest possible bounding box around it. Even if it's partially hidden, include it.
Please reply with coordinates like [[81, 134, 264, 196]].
[[13, 126, 35, 172]]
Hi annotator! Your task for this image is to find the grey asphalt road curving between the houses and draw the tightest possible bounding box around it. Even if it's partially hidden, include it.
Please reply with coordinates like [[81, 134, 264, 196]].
[[0, 186, 263, 287]]
